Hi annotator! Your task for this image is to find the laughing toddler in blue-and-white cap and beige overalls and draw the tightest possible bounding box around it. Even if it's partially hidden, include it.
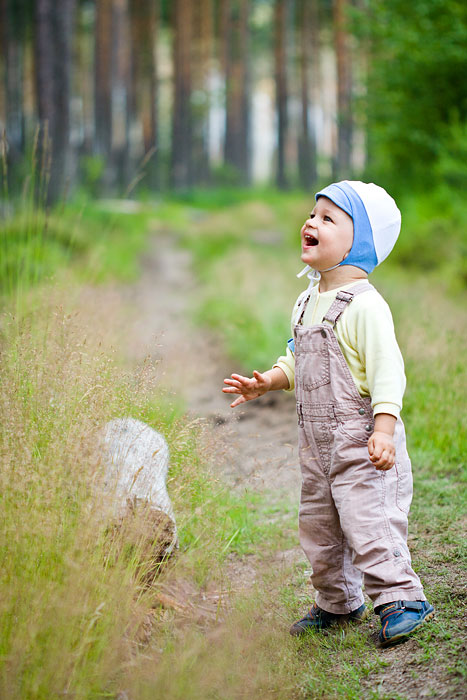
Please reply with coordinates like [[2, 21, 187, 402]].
[[223, 180, 434, 646]]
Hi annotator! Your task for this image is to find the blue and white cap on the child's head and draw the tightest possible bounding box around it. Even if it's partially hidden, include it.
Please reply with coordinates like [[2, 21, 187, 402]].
[[315, 180, 401, 273]]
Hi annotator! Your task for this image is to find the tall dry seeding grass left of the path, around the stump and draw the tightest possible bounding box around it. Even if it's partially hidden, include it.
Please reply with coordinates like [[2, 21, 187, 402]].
[[0, 153, 304, 700]]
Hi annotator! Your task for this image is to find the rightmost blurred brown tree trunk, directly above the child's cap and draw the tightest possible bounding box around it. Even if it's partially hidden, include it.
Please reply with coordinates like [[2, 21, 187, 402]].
[[334, 0, 352, 179]]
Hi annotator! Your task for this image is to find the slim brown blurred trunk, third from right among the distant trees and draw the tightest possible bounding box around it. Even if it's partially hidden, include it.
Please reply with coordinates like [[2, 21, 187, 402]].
[[274, 0, 289, 189]]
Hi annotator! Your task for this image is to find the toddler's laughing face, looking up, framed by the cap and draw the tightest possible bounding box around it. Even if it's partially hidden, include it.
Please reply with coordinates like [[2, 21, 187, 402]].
[[300, 197, 353, 271]]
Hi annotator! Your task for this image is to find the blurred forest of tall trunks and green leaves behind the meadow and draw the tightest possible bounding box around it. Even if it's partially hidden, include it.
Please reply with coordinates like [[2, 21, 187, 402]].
[[0, 0, 467, 202]]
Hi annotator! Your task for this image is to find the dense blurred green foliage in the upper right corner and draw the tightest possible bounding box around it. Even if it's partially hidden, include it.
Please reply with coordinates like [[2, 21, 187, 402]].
[[354, 0, 467, 192]]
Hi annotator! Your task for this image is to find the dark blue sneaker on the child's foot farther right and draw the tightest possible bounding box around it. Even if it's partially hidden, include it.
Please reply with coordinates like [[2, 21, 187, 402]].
[[375, 600, 435, 647]]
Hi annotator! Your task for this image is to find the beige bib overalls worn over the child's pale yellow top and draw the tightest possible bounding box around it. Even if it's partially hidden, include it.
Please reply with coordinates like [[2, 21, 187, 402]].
[[294, 283, 426, 614]]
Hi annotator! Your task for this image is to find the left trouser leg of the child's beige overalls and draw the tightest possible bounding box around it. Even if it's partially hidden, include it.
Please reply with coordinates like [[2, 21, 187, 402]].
[[299, 424, 363, 615]]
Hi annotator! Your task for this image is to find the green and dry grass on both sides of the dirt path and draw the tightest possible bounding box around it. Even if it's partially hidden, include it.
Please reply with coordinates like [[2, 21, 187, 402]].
[[0, 183, 466, 700]]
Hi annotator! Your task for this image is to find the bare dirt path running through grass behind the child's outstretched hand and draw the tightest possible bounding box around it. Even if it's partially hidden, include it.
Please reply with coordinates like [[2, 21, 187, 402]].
[[127, 234, 300, 503]]
